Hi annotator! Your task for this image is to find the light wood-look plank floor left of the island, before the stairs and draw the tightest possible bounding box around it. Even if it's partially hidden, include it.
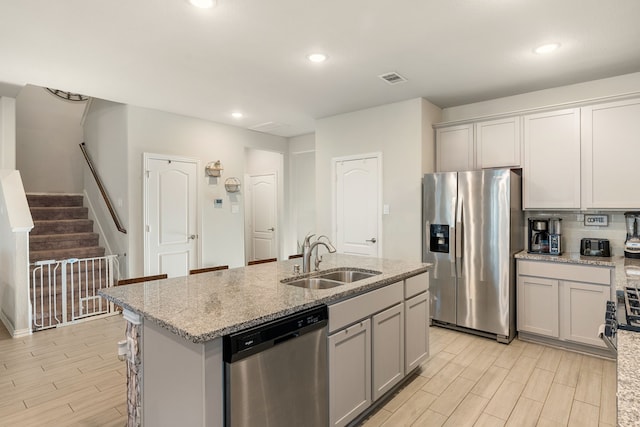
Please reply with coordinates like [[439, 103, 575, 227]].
[[0, 316, 127, 427]]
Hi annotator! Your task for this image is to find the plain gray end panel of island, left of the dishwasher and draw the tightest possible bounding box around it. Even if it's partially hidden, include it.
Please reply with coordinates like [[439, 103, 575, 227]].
[[142, 319, 224, 427]]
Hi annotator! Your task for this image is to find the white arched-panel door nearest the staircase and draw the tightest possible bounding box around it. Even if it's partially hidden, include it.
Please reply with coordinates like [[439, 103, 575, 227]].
[[144, 155, 198, 277]]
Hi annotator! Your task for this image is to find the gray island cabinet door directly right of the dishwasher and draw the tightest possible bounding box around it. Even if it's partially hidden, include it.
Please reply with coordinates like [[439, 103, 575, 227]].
[[329, 319, 371, 426]]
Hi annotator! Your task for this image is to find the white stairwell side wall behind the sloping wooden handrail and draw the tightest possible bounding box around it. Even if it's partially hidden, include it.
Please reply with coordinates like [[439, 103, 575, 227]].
[[81, 99, 131, 275]]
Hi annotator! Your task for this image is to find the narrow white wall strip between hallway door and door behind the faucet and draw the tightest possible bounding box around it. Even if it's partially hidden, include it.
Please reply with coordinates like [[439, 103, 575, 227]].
[[288, 134, 316, 254]]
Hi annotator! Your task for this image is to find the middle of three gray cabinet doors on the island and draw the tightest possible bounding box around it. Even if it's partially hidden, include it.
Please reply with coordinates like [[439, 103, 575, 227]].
[[372, 303, 404, 401]]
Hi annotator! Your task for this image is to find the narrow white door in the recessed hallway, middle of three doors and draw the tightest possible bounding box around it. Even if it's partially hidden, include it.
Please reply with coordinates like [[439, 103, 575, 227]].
[[248, 173, 278, 261]]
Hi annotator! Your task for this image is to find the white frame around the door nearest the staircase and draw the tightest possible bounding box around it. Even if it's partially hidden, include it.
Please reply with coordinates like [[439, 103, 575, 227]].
[[142, 152, 202, 276]]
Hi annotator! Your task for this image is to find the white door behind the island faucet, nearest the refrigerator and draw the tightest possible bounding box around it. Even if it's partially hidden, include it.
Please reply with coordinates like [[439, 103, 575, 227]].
[[334, 155, 382, 257]]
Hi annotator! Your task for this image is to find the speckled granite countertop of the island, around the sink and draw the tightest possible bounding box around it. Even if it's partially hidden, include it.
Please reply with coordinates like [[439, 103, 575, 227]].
[[100, 254, 431, 343]]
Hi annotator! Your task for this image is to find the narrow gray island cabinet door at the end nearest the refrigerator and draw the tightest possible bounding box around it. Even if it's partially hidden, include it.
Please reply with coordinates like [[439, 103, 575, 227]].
[[404, 290, 429, 375]]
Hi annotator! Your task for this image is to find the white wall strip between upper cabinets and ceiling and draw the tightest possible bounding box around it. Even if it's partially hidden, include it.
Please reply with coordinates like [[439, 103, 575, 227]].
[[442, 72, 640, 122]]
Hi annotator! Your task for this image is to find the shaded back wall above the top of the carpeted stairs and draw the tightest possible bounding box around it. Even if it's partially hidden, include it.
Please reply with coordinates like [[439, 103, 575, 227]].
[[16, 85, 87, 193]]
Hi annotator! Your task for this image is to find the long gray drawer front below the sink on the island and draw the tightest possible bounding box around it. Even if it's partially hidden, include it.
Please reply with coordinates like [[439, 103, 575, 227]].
[[329, 282, 403, 333]]
